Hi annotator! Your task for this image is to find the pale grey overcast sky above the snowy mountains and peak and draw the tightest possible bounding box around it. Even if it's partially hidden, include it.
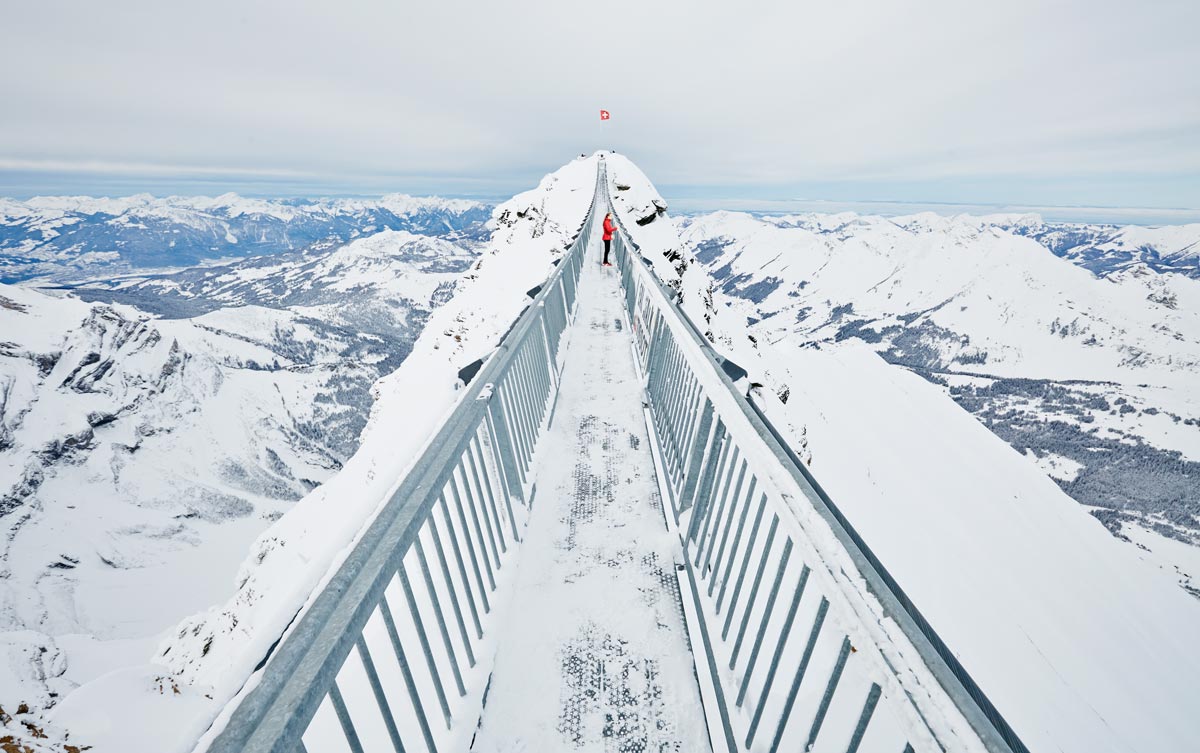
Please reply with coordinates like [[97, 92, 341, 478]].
[[0, 0, 1200, 209]]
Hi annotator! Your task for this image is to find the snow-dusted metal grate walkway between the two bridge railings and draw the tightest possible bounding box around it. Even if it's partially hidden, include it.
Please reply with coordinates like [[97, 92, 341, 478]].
[[472, 223, 709, 753]]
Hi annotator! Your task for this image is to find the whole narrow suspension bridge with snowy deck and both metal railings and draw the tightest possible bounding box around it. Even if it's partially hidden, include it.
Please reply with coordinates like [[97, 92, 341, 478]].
[[199, 161, 1026, 753]]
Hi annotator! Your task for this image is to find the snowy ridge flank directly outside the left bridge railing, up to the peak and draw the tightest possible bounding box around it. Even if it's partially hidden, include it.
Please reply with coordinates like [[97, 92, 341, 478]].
[[42, 157, 596, 753]]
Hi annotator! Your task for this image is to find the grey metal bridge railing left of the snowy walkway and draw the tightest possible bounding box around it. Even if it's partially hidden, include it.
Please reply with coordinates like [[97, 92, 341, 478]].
[[200, 168, 602, 753]]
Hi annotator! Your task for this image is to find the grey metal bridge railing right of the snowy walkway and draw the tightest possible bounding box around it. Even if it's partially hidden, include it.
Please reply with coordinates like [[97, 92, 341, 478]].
[[604, 180, 1025, 753]]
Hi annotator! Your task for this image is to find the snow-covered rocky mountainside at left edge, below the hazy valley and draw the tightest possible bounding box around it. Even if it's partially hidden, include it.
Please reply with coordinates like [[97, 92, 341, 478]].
[[0, 287, 350, 705]]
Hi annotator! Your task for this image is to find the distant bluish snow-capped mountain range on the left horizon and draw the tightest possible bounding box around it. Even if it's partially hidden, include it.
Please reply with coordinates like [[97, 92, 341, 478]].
[[0, 193, 490, 283]]
